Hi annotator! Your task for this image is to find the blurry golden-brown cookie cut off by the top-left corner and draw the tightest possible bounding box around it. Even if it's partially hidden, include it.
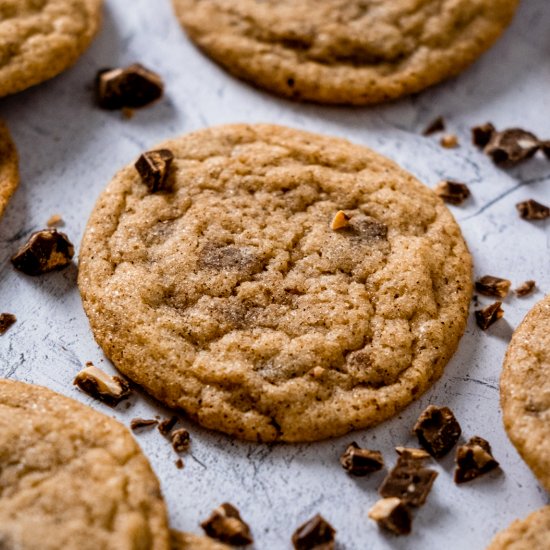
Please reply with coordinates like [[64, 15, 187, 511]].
[[0, 0, 103, 97]]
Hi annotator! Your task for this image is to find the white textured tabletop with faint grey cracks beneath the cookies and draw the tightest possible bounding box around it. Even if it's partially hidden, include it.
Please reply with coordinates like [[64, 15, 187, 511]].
[[0, 0, 550, 550]]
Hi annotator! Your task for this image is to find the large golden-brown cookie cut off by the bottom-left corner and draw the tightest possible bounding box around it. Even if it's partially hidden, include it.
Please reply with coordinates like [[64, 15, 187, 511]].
[[0, 380, 170, 550]]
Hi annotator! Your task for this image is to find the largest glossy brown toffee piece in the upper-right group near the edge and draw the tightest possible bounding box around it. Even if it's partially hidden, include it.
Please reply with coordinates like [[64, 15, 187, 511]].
[[483, 128, 540, 166]]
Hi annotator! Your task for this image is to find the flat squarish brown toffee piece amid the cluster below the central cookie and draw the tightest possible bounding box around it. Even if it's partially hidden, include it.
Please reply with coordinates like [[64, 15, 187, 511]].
[[379, 453, 437, 506]]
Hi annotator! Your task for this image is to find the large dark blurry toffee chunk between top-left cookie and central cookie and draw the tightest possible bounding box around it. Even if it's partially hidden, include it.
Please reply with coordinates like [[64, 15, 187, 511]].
[[96, 63, 164, 110]]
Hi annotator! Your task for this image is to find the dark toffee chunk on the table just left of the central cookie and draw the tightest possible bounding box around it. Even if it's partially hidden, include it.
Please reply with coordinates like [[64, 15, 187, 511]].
[[11, 229, 74, 275]]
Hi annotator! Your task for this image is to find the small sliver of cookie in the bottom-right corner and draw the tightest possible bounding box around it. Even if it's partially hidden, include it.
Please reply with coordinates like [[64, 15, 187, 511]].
[[487, 506, 550, 550]]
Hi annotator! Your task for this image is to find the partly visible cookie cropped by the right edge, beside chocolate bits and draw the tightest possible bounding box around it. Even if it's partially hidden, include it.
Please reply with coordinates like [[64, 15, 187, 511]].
[[500, 295, 550, 491]]
